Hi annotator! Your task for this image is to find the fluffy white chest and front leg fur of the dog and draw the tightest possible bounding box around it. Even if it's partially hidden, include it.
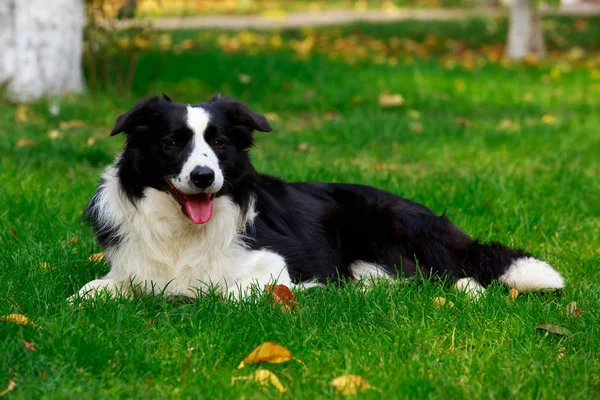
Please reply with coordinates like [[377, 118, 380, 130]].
[[72, 166, 292, 297]]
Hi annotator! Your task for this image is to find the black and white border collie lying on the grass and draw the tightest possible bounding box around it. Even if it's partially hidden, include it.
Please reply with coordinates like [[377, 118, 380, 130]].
[[72, 95, 564, 297]]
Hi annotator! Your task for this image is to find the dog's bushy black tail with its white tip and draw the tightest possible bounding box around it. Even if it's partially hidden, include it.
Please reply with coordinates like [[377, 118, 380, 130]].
[[459, 241, 565, 292]]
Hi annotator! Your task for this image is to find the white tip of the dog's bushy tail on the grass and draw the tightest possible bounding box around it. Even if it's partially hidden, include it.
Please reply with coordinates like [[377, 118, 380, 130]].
[[498, 257, 565, 292]]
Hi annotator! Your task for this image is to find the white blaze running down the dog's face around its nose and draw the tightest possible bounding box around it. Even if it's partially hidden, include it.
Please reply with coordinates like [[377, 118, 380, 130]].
[[172, 106, 223, 194]]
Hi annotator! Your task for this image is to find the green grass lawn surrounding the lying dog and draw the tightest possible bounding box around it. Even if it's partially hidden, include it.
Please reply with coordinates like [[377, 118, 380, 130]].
[[0, 18, 600, 399]]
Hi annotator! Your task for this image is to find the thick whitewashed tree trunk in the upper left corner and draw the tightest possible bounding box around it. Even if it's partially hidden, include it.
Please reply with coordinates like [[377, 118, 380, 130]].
[[0, 0, 85, 101]]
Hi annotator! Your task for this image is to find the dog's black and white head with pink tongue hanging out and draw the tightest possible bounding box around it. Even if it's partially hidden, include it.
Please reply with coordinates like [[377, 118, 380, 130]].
[[110, 94, 272, 224]]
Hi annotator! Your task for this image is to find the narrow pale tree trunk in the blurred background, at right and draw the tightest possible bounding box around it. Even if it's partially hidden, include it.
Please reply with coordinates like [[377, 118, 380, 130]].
[[506, 0, 546, 59]]
